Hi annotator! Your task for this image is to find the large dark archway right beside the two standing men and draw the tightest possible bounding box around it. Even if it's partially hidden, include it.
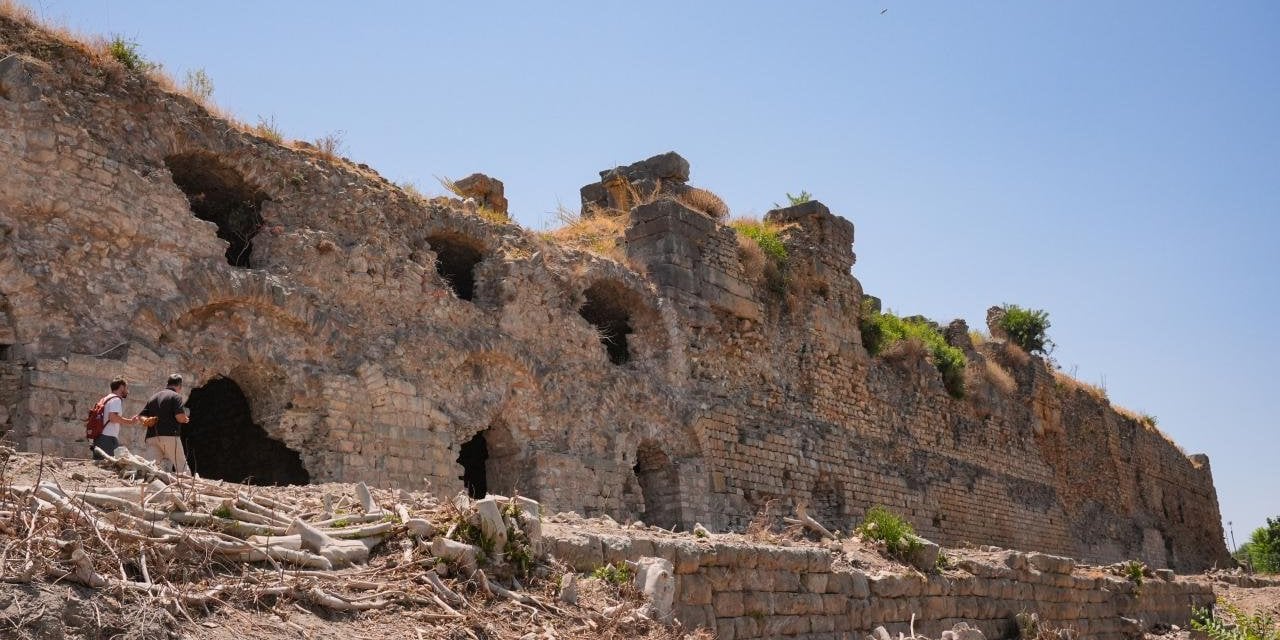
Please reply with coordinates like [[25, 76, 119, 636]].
[[182, 378, 311, 485]]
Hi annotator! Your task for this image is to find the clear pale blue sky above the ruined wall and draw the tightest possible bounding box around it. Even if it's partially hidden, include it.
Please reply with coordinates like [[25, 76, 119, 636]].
[[28, 0, 1280, 550]]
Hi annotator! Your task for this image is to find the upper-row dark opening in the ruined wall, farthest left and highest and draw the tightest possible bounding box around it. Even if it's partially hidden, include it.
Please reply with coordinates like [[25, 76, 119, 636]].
[[164, 151, 266, 268]]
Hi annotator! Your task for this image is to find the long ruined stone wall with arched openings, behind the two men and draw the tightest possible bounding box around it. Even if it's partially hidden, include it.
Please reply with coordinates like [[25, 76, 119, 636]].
[[0, 18, 1228, 570]]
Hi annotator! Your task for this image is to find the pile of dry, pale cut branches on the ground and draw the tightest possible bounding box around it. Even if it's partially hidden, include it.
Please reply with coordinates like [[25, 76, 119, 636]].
[[0, 449, 581, 632]]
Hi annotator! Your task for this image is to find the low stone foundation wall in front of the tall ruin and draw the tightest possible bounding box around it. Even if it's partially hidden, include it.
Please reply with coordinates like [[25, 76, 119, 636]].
[[544, 525, 1213, 640]]
